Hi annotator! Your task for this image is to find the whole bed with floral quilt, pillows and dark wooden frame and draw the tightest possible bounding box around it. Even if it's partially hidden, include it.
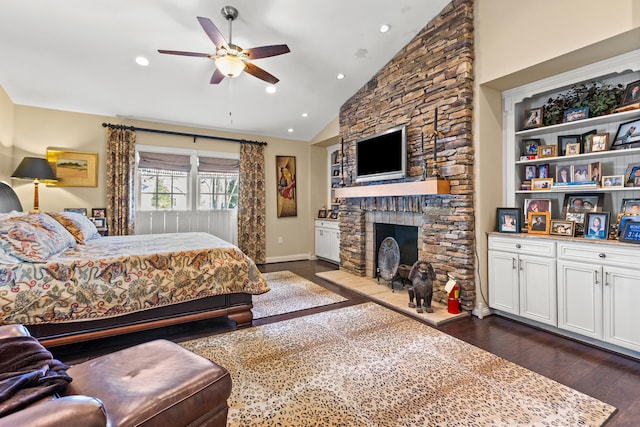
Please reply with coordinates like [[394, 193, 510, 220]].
[[0, 183, 269, 347]]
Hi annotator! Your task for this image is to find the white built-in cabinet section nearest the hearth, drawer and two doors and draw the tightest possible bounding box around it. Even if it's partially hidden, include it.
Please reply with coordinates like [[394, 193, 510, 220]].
[[489, 235, 557, 326]]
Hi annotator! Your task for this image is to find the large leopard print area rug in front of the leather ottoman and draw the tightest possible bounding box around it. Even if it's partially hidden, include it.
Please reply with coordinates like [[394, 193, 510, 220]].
[[182, 303, 616, 427]]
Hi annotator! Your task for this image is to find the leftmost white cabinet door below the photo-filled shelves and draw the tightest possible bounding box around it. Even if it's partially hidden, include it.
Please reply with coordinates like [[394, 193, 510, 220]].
[[489, 251, 519, 314]]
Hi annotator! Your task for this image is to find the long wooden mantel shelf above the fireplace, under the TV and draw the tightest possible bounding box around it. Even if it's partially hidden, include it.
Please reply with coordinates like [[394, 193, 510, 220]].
[[334, 178, 450, 199]]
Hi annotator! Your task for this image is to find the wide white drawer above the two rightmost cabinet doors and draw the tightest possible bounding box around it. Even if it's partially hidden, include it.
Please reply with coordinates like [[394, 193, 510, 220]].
[[558, 242, 640, 267]]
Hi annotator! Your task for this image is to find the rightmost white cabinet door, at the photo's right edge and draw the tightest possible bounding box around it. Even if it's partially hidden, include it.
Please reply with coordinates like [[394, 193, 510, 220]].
[[603, 267, 640, 351]]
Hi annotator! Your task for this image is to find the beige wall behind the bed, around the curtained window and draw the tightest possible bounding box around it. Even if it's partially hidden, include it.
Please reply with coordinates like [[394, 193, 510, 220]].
[[0, 104, 312, 262]]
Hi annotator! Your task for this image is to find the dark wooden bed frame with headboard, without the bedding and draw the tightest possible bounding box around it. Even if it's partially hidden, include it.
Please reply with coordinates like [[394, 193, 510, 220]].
[[0, 182, 253, 347]]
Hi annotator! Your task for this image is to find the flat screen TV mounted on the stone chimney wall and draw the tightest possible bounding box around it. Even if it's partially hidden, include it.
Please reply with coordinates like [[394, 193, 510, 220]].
[[356, 125, 407, 182]]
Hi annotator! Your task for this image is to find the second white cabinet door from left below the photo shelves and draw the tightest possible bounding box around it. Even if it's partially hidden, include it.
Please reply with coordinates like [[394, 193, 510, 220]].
[[518, 255, 558, 326]]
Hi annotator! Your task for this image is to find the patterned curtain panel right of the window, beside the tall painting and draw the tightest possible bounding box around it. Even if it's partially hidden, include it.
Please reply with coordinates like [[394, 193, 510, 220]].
[[238, 143, 267, 264]]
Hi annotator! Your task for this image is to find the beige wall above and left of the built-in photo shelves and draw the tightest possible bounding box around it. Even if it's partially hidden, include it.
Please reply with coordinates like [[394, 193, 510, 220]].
[[474, 0, 640, 309]]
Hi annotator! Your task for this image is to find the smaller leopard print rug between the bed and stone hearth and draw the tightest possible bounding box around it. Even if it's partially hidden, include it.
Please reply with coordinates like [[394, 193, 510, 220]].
[[251, 271, 347, 319]]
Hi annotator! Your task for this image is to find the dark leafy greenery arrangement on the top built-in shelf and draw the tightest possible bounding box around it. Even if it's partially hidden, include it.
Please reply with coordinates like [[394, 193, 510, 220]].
[[543, 82, 624, 126]]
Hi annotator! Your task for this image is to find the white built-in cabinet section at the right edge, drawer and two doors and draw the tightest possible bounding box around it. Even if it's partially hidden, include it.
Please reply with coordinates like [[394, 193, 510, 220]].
[[558, 242, 640, 351]]
